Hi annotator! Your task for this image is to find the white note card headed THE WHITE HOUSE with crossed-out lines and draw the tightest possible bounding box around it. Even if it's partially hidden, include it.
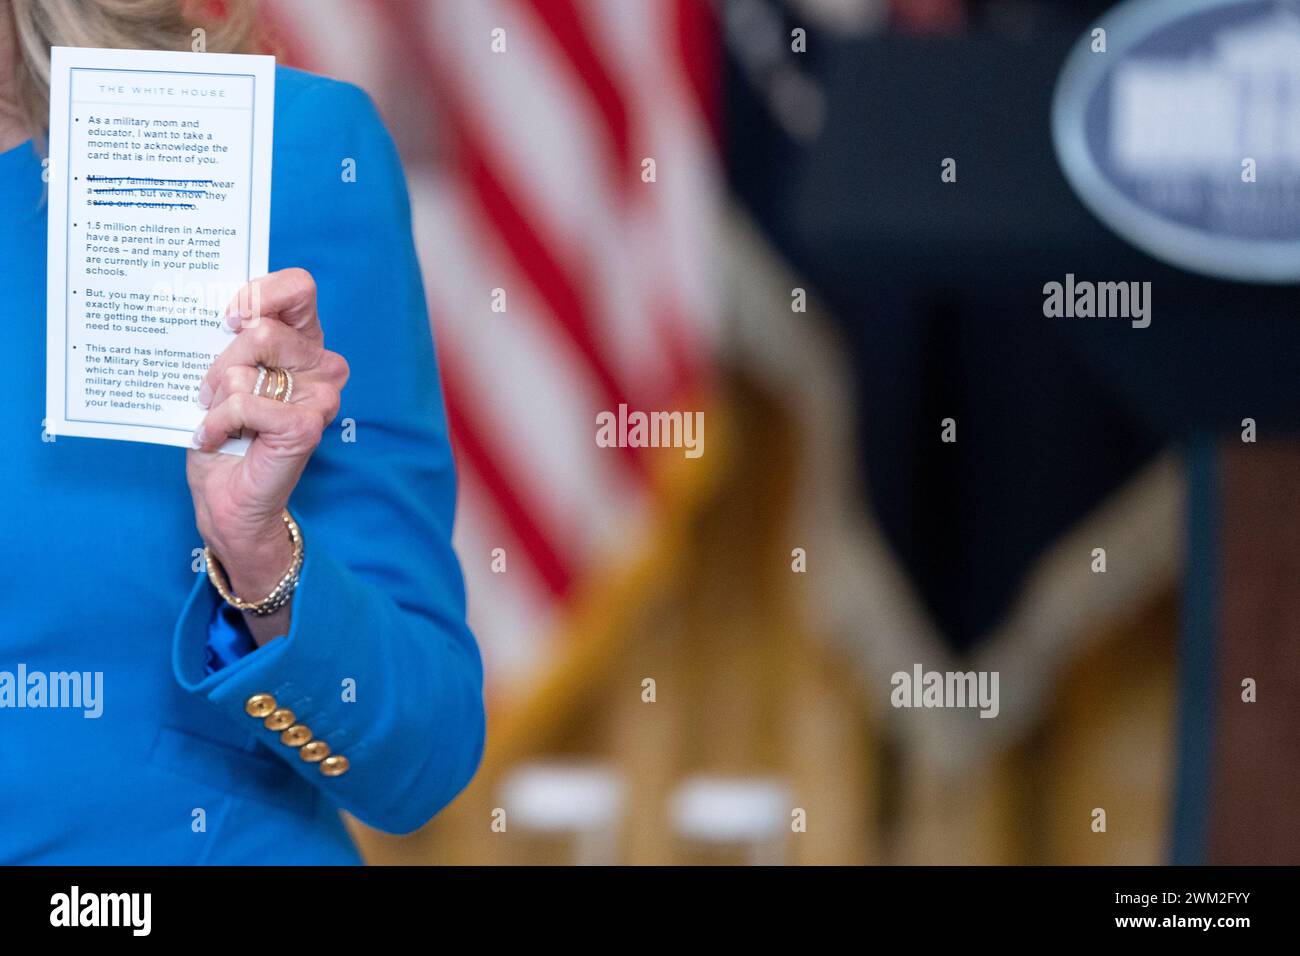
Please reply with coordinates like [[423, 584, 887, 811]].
[[46, 47, 276, 454]]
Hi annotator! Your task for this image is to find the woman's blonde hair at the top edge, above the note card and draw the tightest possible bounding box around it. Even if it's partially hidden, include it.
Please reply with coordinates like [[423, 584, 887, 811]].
[[9, 0, 257, 137]]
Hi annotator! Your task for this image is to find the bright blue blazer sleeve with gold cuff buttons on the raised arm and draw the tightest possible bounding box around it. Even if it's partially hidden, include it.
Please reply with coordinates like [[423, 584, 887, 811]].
[[173, 69, 485, 832]]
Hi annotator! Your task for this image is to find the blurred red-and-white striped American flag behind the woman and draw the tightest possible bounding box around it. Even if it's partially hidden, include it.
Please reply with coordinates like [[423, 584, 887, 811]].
[[254, 0, 722, 700]]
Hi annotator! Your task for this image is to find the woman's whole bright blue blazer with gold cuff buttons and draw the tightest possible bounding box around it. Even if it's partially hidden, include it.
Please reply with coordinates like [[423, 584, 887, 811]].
[[0, 68, 484, 864]]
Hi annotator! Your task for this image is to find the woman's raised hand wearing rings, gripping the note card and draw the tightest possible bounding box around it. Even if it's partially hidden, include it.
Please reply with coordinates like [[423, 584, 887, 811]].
[[186, 269, 347, 644]]
